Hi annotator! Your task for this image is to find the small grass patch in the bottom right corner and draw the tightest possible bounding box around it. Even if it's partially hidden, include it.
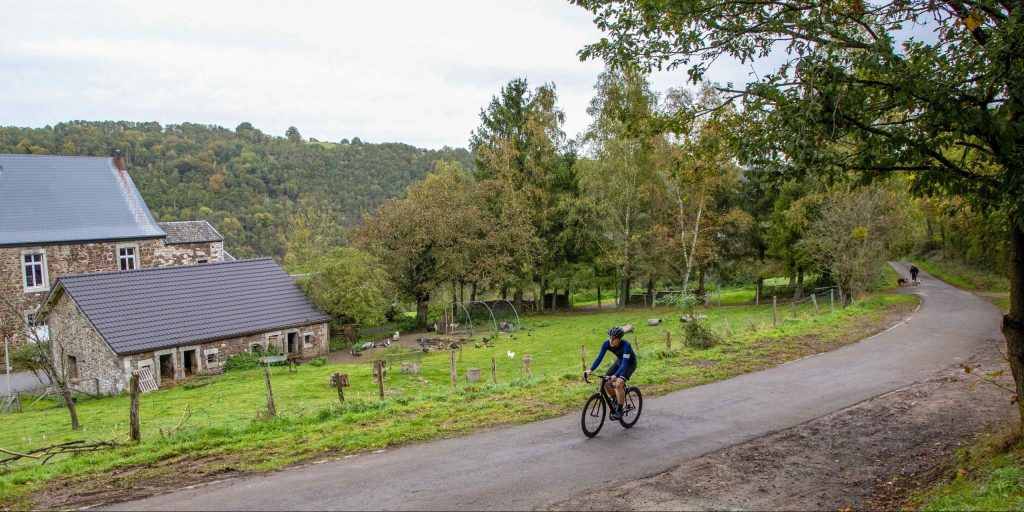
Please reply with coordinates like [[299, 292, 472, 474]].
[[907, 432, 1024, 511]]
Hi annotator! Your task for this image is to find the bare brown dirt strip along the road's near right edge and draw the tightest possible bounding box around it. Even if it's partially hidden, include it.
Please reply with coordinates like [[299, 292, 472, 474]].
[[550, 340, 1018, 510]]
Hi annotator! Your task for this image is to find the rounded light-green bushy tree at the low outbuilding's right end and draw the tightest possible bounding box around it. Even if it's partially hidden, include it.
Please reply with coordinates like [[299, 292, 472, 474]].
[[298, 247, 396, 327]]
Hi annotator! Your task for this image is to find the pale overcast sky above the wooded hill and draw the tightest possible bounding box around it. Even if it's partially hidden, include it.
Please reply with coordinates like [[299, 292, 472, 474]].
[[0, 0, 798, 147]]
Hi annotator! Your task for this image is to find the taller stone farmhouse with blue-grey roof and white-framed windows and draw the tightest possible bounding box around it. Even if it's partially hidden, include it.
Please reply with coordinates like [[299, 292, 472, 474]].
[[0, 153, 233, 354]]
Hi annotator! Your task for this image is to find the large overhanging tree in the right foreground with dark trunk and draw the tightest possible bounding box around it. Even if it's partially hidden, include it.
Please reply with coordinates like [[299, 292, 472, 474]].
[[577, 0, 1024, 426]]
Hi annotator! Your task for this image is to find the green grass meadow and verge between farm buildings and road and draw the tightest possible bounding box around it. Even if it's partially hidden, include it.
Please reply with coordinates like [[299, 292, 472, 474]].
[[0, 295, 916, 508]]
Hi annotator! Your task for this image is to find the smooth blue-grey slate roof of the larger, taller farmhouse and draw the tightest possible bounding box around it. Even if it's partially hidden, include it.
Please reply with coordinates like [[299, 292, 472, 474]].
[[0, 154, 164, 247]]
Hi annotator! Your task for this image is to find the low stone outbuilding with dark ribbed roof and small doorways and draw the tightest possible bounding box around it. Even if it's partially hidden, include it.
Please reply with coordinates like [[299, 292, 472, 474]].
[[40, 258, 330, 393]]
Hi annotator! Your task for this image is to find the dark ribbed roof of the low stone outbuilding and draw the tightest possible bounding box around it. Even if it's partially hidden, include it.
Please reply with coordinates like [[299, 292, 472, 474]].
[[47, 258, 329, 355]]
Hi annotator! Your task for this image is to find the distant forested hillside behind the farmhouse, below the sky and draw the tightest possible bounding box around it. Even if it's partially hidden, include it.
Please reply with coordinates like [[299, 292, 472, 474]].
[[0, 121, 472, 260]]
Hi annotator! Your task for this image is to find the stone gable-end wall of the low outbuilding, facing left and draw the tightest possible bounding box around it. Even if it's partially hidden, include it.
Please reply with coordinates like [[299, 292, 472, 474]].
[[47, 294, 127, 394]]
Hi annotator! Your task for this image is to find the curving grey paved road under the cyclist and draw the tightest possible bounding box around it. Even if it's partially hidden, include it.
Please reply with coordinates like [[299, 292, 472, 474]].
[[119, 264, 1000, 510]]
